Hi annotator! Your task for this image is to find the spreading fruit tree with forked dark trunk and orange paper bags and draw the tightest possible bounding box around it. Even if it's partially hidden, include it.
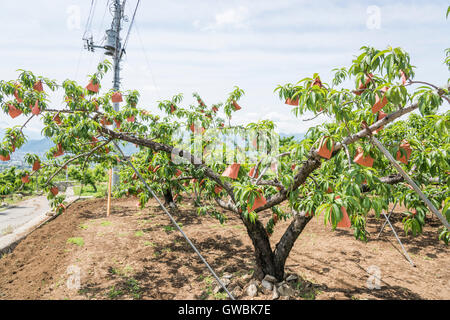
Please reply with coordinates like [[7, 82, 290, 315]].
[[0, 47, 450, 280]]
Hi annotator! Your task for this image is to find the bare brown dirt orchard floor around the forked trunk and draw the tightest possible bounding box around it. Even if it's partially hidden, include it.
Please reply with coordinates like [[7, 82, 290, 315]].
[[0, 198, 450, 299]]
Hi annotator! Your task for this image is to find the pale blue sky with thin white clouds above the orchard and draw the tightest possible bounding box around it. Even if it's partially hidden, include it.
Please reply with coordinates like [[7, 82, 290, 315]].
[[0, 0, 450, 139]]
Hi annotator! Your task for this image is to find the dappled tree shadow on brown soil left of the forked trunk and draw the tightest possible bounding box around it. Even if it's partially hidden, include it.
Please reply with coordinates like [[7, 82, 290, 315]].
[[80, 234, 253, 300]]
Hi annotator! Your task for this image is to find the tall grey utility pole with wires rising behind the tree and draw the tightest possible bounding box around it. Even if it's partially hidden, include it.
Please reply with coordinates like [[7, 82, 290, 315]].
[[83, 0, 127, 186]]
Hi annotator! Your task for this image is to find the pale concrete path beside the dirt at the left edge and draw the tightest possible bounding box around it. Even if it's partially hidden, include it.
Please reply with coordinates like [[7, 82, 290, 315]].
[[0, 187, 84, 252]]
